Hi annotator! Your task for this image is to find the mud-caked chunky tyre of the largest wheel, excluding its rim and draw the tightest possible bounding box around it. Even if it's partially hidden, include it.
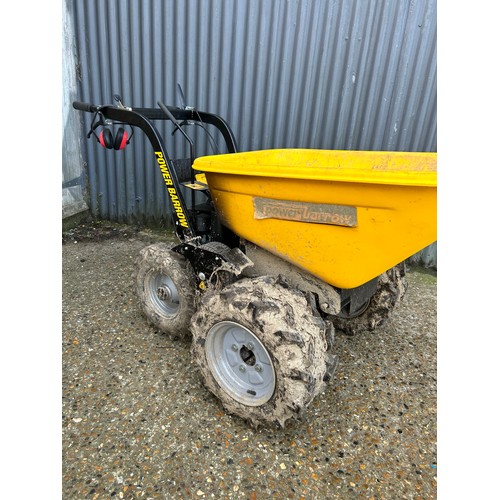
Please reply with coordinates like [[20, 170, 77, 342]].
[[191, 276, 327, 427]]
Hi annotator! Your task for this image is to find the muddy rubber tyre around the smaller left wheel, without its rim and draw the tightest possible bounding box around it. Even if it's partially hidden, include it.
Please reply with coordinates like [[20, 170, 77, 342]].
[[136, 243, 196, 339]]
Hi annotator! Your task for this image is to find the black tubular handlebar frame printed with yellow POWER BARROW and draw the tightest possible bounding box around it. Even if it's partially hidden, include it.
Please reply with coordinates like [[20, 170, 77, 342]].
[[73, 101, 237, 242]]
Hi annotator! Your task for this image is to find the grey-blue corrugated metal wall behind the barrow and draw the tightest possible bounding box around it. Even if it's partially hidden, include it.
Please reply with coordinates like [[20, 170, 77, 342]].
[[68, 0, 437, 266]]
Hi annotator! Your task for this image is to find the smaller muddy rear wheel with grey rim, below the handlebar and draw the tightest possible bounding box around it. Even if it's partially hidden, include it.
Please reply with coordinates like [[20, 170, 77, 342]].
[[136, 243, 196, 339]]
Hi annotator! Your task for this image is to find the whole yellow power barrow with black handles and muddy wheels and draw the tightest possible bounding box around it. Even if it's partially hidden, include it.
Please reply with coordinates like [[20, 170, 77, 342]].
[[73, 96, 437, 426]]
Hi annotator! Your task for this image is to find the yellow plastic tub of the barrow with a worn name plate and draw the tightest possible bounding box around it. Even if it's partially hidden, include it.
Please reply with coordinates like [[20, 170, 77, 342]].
[[193, 149, 437, 288]]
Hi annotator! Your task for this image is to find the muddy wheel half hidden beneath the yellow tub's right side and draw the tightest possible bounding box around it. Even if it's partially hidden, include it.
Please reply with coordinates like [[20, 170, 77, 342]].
[[329, 264, 408, 335]]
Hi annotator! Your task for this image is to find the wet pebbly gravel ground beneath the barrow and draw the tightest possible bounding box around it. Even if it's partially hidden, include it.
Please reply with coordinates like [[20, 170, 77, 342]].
[[62, 223, 437, 500]]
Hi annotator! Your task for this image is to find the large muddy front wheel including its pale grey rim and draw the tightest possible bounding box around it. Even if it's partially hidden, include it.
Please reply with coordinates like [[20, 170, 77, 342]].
[[191, 277, 329, 427]]
